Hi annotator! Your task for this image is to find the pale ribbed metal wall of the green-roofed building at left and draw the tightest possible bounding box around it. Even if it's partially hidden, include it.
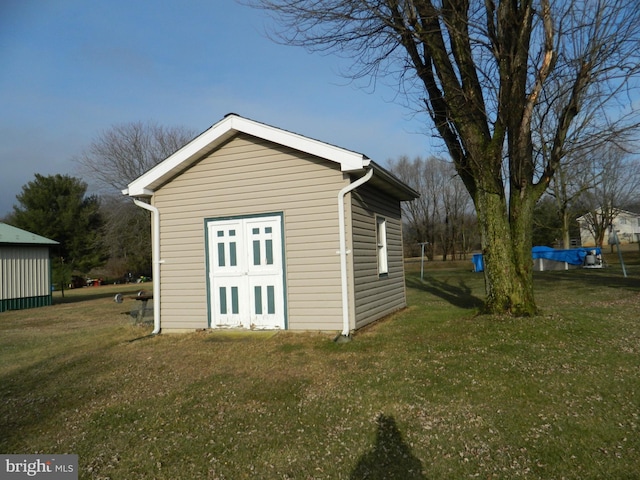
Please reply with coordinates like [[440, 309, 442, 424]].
[[0, 246, 51, 311]]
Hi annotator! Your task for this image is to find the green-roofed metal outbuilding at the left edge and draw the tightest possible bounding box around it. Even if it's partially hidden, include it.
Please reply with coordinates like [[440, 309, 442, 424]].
[[0, 223, 58, 312]]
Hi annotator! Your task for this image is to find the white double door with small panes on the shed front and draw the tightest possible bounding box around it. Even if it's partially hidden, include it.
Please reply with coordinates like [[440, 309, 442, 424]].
[[207, 215, 285, 329]]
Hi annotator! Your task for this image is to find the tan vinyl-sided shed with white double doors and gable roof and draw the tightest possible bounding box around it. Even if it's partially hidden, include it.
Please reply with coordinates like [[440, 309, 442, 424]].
[[123, 114, 418, 336]]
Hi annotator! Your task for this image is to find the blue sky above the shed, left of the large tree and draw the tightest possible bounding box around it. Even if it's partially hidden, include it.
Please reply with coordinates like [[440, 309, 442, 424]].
[[0, 0, 437, 218]]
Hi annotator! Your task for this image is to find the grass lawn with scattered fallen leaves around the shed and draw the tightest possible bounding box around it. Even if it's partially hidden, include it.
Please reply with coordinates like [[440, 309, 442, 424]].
[[0, 251, 640, 480]]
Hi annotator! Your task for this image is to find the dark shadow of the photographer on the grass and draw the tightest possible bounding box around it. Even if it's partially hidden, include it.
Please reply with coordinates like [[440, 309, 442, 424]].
[[349, 414, 427, 480]]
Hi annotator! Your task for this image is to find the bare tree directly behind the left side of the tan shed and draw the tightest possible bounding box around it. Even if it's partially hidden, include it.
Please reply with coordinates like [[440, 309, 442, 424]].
[[75, 122, 195, 275]]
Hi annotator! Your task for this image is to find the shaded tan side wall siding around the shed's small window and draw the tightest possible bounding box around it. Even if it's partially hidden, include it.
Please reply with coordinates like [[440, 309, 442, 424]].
[[351, 184, 406, 328]]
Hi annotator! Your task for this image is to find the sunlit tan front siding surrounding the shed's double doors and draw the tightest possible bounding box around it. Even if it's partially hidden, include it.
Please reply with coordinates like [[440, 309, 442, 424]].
[[153, 134, 348, 331]]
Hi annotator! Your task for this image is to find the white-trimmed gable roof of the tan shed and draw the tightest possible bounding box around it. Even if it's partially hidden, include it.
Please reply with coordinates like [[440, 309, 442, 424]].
[[122, 113, 419, 200]]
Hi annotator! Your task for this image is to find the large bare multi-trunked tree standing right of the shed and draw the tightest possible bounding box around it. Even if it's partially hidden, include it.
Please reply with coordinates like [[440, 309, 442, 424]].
[[252, 0, 640, 315]]
